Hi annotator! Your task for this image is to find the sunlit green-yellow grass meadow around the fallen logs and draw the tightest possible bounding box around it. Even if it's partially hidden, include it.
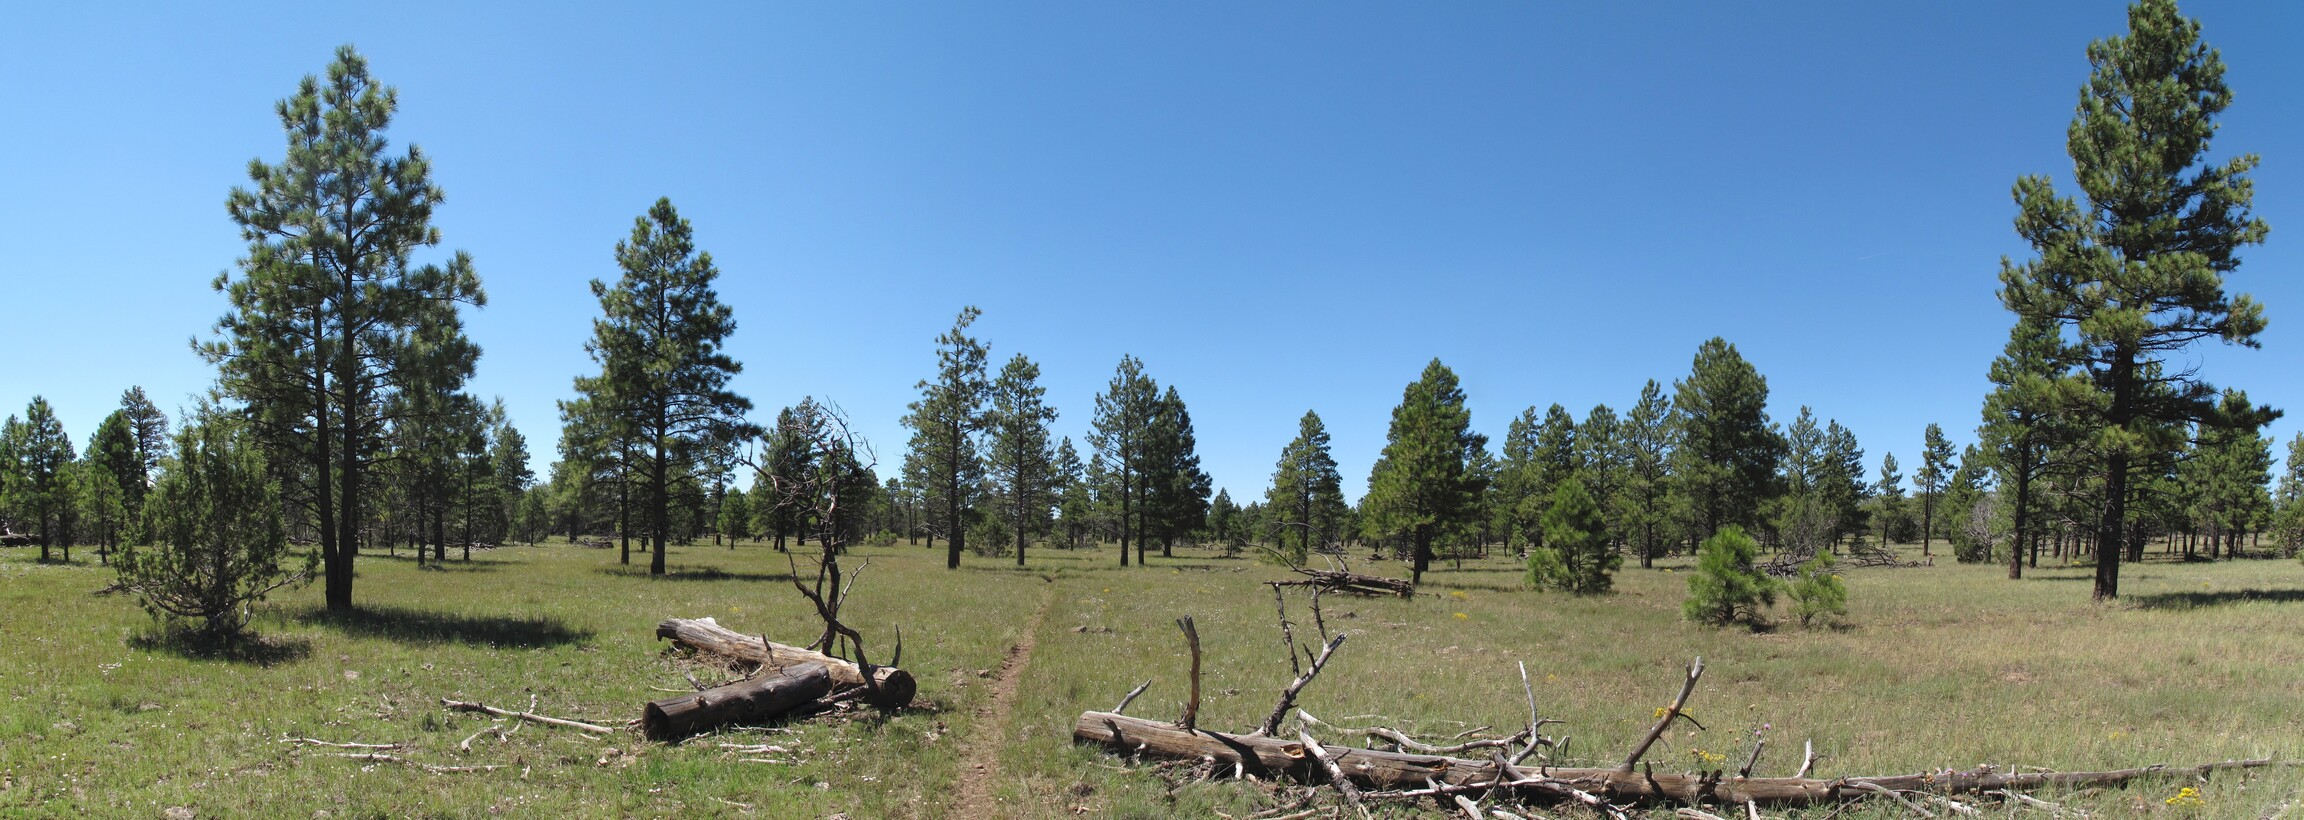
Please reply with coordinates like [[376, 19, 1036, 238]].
[[0, 544, 2304, 818]]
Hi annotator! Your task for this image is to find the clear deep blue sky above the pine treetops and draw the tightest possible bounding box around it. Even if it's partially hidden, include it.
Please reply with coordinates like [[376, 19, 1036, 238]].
[[0, 0, 2304, 502]]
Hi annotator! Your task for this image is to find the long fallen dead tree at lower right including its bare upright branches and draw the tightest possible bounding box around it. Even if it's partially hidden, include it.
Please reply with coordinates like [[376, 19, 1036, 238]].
[[1071, 585, 2272, 818]]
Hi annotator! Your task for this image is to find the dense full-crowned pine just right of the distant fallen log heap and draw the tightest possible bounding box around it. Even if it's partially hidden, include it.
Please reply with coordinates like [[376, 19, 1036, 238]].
[[1362, 359, 1488, 583]]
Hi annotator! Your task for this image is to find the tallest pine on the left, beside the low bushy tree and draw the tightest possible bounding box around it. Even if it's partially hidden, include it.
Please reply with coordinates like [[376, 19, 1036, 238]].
[[200, 46, 486, 613]]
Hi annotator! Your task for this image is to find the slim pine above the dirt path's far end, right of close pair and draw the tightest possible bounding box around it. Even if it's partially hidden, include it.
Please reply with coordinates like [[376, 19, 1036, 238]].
[[986, 352, 1058, 567]]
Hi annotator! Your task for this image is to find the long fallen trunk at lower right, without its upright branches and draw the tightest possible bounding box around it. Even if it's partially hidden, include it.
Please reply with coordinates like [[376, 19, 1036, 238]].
[[1071, 712, 2274, 808]]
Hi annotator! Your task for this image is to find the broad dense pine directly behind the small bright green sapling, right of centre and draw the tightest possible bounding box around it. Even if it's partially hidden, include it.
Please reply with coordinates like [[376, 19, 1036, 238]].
[[1673, 336, 1783, 537]]
